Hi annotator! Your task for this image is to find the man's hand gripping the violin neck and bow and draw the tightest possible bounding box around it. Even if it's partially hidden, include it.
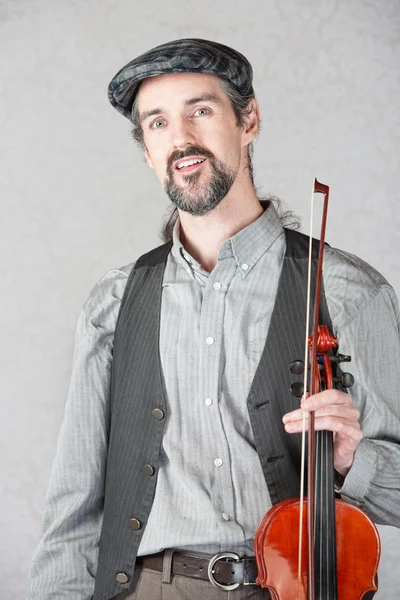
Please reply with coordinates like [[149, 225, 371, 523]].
[[282, 390, 363, 477]]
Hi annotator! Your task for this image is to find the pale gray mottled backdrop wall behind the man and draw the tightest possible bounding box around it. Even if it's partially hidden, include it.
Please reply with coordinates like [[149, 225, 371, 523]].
[[0, 0, 400, 600]]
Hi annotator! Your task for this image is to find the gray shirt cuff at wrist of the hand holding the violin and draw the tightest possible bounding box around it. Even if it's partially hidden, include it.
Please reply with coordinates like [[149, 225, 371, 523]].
[[335, 439, 377, 505]]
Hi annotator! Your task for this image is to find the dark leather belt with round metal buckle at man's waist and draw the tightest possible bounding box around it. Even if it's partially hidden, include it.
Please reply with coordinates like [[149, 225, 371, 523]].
[[136, 551, 257, 591]]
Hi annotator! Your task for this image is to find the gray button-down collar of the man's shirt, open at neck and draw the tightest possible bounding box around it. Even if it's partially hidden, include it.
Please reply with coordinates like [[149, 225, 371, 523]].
[[172, 202, 283, 279]]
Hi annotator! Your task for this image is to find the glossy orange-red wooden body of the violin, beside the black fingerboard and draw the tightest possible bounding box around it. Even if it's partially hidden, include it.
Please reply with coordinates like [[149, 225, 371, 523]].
[[254, 498, 380, 600]]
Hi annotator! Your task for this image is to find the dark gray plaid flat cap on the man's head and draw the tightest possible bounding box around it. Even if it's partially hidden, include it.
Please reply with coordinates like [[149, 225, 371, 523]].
[[108, 38, 254, 119]]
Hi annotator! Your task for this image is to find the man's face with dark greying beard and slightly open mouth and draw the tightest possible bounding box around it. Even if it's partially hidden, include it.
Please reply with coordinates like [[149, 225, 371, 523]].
[[138, 73, 248, 215]]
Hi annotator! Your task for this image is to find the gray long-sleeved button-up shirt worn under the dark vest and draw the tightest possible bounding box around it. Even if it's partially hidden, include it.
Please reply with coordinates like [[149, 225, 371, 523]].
[[29, 206, 400, 600]]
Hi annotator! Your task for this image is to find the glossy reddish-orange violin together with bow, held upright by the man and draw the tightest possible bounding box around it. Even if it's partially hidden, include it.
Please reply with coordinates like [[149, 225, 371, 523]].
[[254, 179, 380, 600]]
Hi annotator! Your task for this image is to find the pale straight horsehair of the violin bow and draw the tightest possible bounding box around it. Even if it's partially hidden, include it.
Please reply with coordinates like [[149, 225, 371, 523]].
[[297, 185, 314, 585]]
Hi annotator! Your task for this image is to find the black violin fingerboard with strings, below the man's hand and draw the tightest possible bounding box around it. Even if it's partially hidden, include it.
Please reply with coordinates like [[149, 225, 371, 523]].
[[314, 431, 338, 600]]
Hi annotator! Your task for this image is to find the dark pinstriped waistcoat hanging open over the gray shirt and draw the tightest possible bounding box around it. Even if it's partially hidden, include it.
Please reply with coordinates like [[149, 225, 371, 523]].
[[93, 229, 331, 600]]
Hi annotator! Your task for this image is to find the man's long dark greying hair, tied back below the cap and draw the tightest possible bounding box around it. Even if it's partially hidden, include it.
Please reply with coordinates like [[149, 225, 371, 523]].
[[131, 75, 300, 242]]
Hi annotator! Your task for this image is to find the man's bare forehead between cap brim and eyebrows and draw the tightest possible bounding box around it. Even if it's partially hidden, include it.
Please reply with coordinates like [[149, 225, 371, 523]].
[[137, 73, 228, 112]]
